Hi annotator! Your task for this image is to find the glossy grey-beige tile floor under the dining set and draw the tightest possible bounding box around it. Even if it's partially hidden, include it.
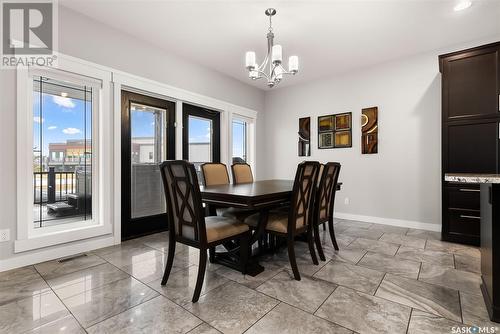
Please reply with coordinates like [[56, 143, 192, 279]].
[[0, 220, 500, 334]]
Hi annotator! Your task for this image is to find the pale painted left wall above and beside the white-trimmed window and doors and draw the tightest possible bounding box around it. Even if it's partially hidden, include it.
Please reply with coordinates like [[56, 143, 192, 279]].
[[0, 7, 264, 267]]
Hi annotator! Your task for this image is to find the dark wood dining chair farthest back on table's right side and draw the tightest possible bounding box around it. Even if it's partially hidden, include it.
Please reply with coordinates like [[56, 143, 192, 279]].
[[312, 162, 340, 261]]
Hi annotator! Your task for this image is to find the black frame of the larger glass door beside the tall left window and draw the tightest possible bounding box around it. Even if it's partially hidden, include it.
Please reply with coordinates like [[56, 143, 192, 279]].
[[121, 90, 175, 241]]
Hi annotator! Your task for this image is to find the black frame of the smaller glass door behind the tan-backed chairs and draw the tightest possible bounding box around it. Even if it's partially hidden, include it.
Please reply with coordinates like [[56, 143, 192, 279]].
[[182, 103, 220, 162]]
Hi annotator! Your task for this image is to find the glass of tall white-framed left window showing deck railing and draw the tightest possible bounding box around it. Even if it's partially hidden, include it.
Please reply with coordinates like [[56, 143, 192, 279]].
[[33, 77, 93, 228]]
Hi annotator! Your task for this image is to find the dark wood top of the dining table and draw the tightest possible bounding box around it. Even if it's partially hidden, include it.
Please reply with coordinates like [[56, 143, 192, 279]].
[[200, 180, 341, 208]]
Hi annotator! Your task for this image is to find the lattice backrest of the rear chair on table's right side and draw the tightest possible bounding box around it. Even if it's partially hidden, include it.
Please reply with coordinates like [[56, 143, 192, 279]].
[[314, 162, 340, 222]]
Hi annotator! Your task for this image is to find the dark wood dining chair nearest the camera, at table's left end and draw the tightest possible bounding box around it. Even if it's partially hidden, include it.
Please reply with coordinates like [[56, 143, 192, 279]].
[[160, 160, 250, 303]]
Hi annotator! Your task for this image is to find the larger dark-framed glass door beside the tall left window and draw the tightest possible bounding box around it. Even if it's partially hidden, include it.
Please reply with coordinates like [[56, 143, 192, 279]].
[[121, 91, 175, 240]]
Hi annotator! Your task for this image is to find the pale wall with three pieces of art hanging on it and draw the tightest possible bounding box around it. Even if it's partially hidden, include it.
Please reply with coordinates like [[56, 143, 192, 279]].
[[260, 38, 498, 230]]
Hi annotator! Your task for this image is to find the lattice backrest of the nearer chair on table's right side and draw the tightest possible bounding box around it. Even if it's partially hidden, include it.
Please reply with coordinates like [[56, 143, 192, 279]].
[[288, 161, 320, 232]]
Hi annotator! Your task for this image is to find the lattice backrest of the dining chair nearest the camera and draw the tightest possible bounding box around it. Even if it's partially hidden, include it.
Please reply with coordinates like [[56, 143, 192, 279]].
[[160, 160, 207, 245]]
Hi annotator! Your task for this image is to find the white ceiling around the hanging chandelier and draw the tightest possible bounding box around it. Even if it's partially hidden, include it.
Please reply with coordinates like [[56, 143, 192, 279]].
[[59, 0, 500, 89]]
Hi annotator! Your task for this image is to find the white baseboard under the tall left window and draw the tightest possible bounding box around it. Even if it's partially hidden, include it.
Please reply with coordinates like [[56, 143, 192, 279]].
[[0, 236, 115, 272]]
